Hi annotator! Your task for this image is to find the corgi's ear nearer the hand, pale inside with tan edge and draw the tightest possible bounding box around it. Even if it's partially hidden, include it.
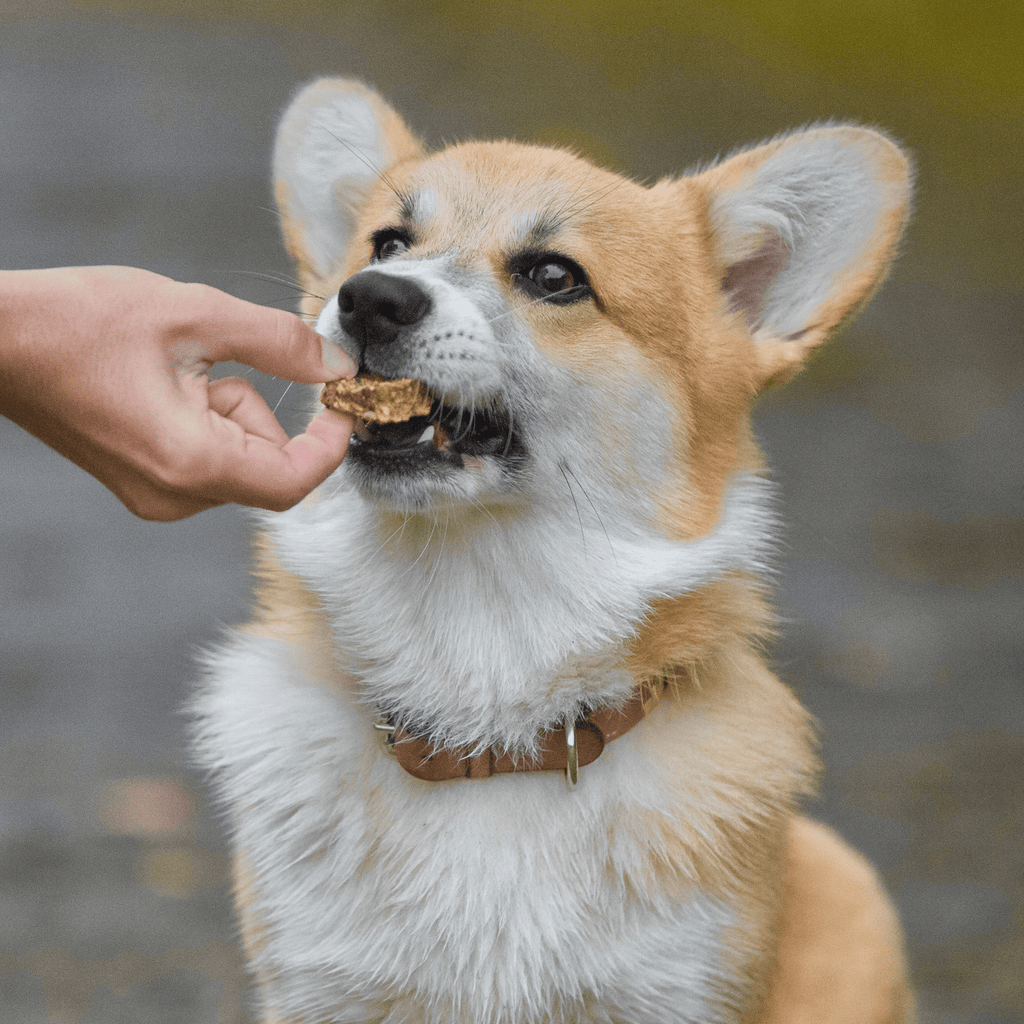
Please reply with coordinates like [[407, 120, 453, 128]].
[[273, 78, 423, 292]]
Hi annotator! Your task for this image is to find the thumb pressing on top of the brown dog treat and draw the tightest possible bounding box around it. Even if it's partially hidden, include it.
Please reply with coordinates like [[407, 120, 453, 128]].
[[193, 289, 358, 384]]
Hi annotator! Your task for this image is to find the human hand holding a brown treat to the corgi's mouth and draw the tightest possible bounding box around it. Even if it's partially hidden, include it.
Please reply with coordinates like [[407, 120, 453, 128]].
[[0, 267, 355, 520]]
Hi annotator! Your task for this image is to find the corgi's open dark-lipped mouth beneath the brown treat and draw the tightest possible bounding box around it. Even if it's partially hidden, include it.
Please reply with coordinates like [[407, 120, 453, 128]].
[[349, 396, 525, 474]]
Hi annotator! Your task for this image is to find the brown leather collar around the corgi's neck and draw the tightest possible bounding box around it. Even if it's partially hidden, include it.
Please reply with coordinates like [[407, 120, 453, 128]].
[[377, 677, 669, 782]]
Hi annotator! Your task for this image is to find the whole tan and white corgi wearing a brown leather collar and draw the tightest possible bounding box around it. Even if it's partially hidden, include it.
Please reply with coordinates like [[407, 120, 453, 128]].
[[194, 78, 914, 1024]]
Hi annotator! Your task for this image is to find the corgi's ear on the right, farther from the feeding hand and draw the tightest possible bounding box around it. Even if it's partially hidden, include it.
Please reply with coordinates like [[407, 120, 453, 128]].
[[695, 126, 911, 386]]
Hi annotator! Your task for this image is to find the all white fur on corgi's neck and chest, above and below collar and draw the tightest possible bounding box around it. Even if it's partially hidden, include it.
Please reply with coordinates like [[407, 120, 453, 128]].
[[197, 479, 778, 1024]]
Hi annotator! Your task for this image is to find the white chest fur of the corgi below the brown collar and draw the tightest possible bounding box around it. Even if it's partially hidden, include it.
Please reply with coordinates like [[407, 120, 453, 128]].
[[193, 636, 732, 1024]]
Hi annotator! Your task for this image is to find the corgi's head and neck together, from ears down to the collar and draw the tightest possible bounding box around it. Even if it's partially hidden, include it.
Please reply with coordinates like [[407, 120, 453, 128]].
[[264, 79, 909, 751]]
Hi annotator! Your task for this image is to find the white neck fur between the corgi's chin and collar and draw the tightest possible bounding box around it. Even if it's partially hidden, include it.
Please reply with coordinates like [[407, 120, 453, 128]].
[[270, 468, 770, 758]]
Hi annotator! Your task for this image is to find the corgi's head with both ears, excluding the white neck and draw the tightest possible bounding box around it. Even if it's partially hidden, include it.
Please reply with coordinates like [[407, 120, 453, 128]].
[[274, 79, 909, 540]]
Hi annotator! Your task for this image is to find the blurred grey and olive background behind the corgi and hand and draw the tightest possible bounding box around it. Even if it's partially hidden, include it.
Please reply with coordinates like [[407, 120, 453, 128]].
[[0, 0, 1024, 1024]]
